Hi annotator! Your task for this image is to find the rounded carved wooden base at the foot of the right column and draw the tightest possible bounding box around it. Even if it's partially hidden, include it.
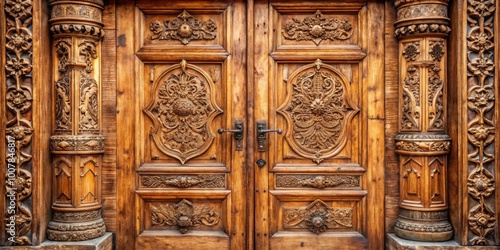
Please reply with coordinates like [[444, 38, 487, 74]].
[[394, 208, 453, 242]]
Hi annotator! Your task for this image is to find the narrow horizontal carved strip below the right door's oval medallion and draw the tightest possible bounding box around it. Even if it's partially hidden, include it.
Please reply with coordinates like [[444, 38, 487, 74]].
[[276, 175, 360, 189]]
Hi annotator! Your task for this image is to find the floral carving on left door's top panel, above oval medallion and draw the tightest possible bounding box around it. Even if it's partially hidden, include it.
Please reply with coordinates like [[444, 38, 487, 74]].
[[149, 10, 217, 45]]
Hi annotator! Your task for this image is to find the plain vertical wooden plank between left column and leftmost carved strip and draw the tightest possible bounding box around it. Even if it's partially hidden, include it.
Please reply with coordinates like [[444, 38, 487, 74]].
[[32, 0, 52, 245]]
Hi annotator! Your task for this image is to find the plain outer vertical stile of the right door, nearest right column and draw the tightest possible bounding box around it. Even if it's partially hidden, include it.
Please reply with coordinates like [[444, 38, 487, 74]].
[[364, 0, 385, 249]]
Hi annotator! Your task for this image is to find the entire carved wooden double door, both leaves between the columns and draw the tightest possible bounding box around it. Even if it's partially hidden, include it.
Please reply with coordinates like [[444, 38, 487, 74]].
[[116, 0, 384, 249]]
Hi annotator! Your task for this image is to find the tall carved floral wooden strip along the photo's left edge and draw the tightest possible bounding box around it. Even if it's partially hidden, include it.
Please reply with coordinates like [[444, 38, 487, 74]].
[[0, 0, 35, 246]]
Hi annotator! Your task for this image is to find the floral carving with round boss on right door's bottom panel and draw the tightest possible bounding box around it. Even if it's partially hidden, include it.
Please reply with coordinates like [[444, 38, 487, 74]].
[[283, 199, 352, 234]]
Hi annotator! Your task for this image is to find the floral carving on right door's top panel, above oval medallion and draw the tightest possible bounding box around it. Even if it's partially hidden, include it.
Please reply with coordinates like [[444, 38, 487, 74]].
[[282, 10, 354, 46]]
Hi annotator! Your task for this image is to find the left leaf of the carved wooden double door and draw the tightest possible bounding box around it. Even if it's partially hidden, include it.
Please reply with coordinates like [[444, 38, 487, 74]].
[[117, 0, 247, 249]]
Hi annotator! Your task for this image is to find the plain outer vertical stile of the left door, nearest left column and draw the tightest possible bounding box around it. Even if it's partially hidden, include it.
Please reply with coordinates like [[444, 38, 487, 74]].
[[116, 0, 137, 249]]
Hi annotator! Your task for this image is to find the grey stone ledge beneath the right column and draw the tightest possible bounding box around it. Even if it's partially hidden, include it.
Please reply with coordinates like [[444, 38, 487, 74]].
[[385, 234, 499, 250]]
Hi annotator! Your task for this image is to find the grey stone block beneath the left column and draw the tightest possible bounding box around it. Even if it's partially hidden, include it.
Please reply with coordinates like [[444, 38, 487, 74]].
[[39, 232, 113, 250]]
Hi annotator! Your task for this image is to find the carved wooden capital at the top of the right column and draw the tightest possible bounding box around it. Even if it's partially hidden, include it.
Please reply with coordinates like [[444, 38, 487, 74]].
[[394, 0, 451, 39]]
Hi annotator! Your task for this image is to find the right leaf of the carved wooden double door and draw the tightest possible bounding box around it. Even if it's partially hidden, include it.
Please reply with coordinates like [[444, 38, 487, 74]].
[[254, 0, 384, 249]]
